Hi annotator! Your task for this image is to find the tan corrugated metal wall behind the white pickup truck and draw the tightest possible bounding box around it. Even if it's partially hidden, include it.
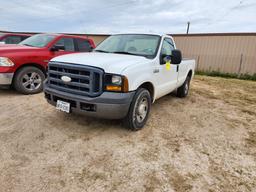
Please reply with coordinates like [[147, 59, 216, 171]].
[[89, 33, 256, 75]]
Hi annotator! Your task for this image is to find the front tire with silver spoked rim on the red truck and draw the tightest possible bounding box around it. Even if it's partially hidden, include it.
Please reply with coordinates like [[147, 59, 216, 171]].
[[13, 66, 45, 95]]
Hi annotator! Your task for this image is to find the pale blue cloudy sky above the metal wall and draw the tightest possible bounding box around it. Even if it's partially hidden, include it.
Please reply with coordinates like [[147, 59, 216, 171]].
[[0, 0, 256, 34]]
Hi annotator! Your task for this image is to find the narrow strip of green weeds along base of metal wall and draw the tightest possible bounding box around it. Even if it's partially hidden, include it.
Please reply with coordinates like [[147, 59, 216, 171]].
[[196, 71, 256, 81]]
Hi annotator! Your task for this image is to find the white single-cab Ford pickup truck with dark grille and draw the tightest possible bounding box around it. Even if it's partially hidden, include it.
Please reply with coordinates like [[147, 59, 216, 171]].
[[44, 34, 195, 130]]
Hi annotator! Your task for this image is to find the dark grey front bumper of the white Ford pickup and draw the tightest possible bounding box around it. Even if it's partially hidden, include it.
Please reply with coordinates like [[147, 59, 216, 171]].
[[44, 84, 135, 119]]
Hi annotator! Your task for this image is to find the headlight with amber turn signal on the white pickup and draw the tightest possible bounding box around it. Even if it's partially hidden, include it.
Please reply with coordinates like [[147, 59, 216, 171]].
[[104, 74, 129, 92]]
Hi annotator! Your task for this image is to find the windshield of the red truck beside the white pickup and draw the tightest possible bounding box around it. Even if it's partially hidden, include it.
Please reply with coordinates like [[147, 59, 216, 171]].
[[19, 34, 55, 47]]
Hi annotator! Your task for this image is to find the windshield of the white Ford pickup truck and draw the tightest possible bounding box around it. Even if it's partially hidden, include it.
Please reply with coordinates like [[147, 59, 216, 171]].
[[94, 34, 161, 58]]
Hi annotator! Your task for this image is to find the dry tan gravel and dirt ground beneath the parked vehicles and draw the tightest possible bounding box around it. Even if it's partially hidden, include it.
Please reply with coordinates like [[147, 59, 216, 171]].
[[0, 76, 256, 192]]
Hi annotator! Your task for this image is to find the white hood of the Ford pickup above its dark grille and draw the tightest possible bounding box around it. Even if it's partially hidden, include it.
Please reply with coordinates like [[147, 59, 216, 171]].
[[51, 52, 152, 74]]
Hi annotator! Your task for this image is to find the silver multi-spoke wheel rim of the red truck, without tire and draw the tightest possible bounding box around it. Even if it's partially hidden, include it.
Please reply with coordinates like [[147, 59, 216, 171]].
[[22, 72, 42, 91]]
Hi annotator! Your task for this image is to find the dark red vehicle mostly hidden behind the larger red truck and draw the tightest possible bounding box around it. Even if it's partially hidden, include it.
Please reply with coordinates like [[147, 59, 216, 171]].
[[0, 33, 31, 44]]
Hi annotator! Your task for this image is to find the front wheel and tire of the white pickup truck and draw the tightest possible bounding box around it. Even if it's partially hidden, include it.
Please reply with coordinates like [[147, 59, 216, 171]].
[[124, 88, 152, 131]]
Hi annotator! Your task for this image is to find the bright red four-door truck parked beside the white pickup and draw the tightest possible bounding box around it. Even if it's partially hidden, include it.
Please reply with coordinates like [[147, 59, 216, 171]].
[[0, 34, 95, 94]]
